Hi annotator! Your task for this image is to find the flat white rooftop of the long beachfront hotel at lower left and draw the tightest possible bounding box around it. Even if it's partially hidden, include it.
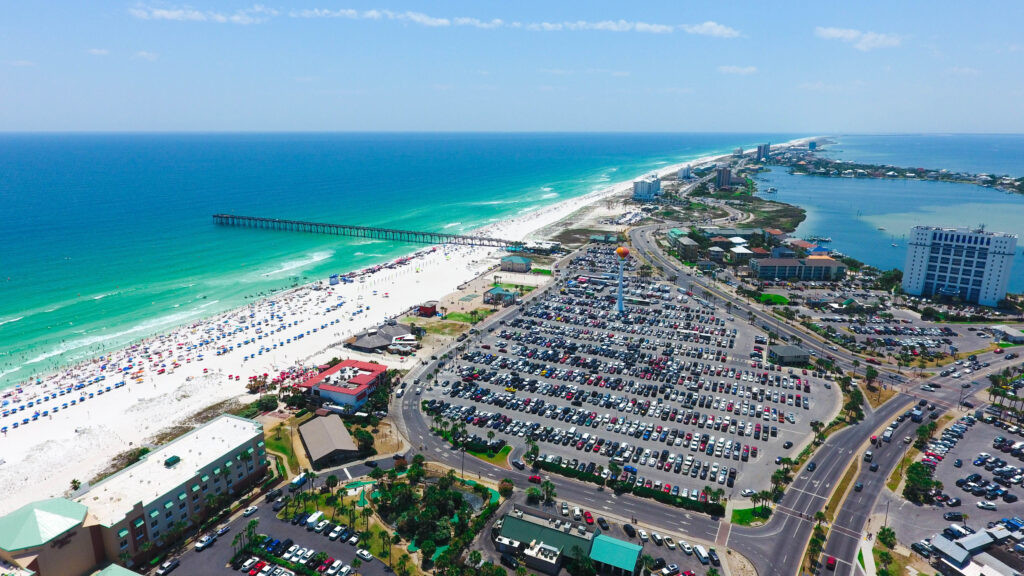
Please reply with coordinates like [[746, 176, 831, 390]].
[[76, 414, 262, 526]]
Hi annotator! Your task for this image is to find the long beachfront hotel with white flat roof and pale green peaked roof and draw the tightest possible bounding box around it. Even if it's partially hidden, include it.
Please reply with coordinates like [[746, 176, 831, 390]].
[[0, 415, 267, 576]]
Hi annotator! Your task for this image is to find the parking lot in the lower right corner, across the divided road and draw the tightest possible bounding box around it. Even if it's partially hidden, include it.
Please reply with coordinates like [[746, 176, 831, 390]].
[[881, 412, 1024, 545]]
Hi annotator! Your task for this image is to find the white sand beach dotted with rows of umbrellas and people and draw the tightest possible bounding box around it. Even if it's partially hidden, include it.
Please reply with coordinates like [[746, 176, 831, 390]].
[[0, 134, 813, 513]]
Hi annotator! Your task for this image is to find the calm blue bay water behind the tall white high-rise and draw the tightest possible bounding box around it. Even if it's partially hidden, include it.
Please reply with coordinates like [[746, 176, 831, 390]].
[[759, 134, 1024, 292]]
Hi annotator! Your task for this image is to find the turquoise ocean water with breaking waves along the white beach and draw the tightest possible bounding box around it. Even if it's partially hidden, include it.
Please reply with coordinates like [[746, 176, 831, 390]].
[[0, 134, 797, 387]]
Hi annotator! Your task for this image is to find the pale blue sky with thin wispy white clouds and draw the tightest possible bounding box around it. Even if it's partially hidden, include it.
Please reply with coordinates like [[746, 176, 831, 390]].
[[0, 0, 1024, 134]]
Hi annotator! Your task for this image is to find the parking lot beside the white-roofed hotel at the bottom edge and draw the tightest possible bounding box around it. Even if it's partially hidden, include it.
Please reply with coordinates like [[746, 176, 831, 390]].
[[159, 504, 388, 576]]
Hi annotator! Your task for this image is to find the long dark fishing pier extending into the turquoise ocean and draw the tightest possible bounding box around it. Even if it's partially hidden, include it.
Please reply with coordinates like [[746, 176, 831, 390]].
[[213, 214, 522, 249]]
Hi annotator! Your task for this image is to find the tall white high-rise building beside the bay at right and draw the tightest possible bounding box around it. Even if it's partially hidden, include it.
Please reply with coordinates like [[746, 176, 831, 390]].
[[903, 227, 1017, 306]]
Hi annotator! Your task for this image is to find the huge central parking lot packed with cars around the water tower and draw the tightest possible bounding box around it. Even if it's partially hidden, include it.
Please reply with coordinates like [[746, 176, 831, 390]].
[[414, 247, 839, 497]]
